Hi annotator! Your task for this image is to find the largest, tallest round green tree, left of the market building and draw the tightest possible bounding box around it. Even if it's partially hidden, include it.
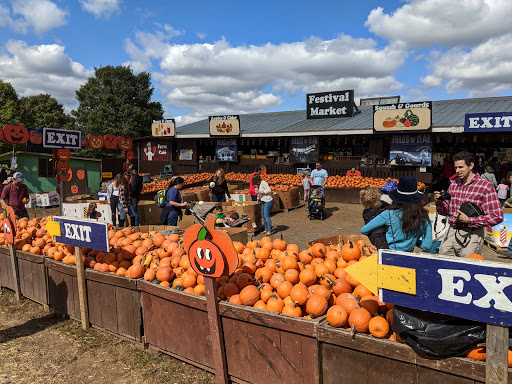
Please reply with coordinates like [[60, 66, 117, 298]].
[[71, 66, 163, 157]]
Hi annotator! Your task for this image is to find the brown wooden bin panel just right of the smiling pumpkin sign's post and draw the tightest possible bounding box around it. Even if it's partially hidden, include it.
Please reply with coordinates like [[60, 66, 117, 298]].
[[219, 302, 320, 384]]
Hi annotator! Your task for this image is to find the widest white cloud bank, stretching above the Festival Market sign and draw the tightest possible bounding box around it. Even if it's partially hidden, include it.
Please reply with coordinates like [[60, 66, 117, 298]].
[[127, 34, 408, 121]]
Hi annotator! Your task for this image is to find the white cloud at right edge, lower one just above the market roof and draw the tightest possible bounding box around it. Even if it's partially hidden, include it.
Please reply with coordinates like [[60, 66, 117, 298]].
[[421, 34, 512, 97]]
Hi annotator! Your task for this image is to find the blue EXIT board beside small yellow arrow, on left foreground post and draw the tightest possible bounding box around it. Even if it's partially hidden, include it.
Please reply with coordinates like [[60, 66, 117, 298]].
[[53, 216, 109, 252]]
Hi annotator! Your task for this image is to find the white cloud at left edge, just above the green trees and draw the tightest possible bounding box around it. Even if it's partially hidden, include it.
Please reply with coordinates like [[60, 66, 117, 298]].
[[0, 40, 94, 106]]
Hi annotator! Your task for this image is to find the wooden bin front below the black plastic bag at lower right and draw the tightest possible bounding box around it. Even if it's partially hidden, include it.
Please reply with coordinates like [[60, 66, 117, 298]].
[[317, 320, 512, 384]]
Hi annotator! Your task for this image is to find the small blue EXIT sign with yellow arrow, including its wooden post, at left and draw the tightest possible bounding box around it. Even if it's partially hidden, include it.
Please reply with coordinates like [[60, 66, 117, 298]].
[[46, 216, 110, 329]]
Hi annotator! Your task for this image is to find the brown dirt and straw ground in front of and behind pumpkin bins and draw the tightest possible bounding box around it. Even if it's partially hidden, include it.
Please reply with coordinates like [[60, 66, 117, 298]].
[[0, 203, 509, 384]]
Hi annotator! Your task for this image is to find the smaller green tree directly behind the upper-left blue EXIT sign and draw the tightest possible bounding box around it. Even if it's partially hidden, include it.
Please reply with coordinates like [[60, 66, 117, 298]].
[[19, 93, 73, 129]]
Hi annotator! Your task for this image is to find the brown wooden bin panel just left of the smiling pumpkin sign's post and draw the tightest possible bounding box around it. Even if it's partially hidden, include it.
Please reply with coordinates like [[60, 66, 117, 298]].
[[137, 280, 214, 372]]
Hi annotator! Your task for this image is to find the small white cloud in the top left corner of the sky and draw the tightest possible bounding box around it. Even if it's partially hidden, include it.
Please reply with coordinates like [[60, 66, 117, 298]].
[[5, 0, 68, 35]]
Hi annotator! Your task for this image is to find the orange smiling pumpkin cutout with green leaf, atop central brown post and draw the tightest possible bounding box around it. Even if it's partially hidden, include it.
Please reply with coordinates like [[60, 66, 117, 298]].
[[183, 215, 238, 277]]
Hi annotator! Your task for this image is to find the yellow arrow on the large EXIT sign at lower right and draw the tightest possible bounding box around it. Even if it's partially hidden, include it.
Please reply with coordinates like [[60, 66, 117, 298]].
[[345, 254, 416, 295]]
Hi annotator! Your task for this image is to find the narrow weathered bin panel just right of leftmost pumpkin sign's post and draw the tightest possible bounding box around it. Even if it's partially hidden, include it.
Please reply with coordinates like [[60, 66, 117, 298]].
[[16, 251, 48, 305]]
